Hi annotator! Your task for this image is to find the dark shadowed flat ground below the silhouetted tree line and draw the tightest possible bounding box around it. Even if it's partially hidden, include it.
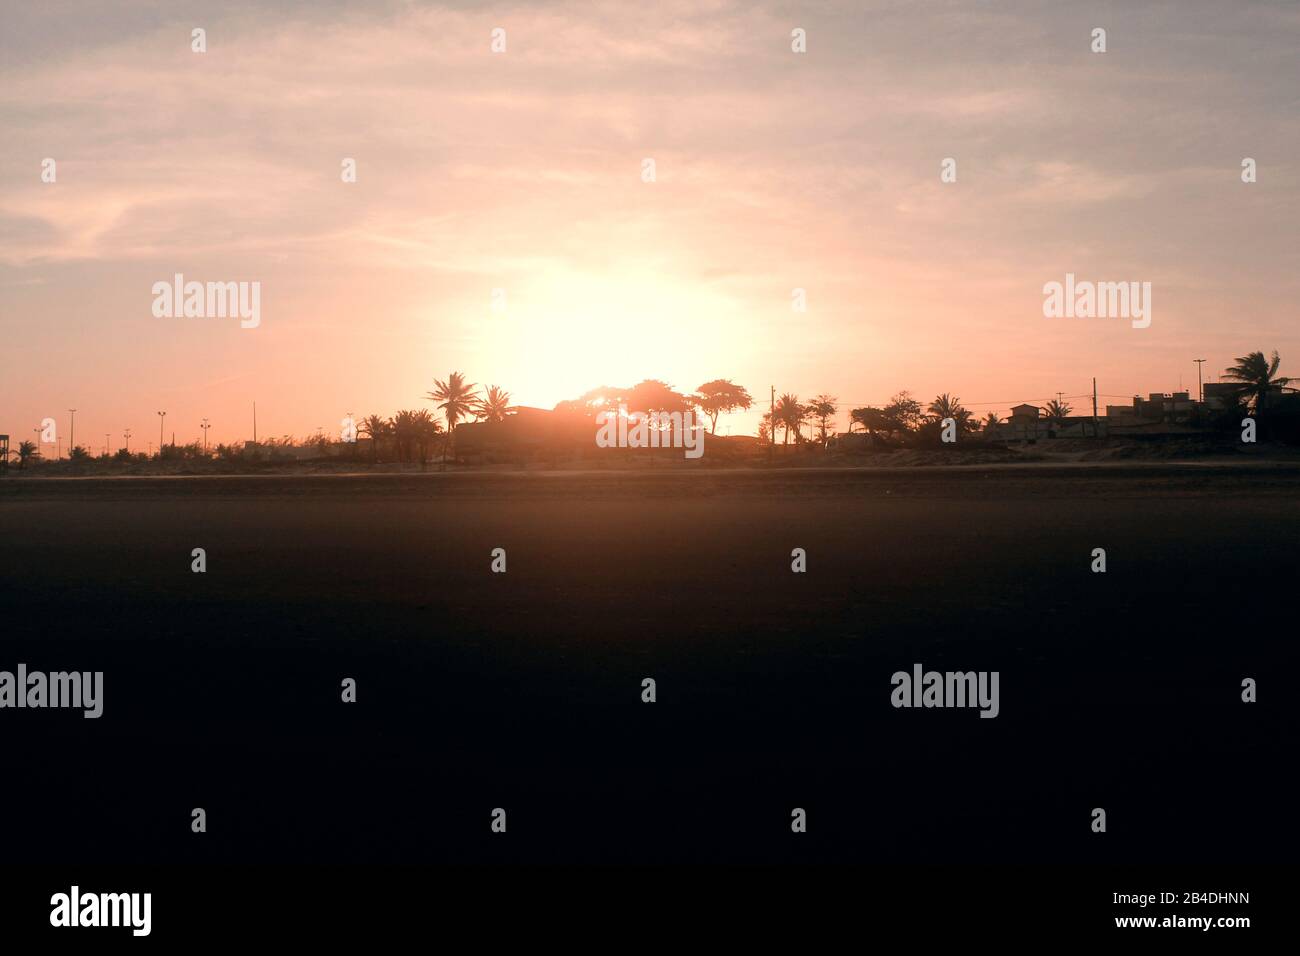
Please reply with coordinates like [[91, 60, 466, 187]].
[[0, 466, 1300, 864]]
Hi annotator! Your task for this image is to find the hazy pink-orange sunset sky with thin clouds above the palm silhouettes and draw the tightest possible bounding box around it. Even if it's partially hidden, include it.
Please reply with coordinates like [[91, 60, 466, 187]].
[[0, 0, 1300, 454]]
